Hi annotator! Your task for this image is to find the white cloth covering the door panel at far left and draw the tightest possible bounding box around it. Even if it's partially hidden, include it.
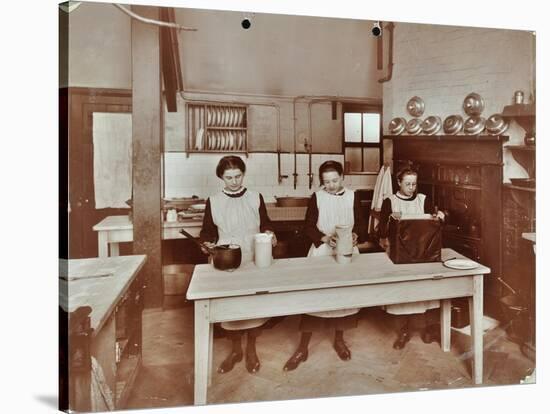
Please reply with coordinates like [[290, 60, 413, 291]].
[[92, 112, 132, 209]]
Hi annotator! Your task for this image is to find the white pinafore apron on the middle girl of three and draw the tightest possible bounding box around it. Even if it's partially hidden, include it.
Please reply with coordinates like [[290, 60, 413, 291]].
[[307, 189, 359, 318]]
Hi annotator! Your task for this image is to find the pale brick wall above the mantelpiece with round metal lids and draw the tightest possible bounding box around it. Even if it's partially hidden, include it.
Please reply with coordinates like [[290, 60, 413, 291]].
[[383, 23, 535, 181]]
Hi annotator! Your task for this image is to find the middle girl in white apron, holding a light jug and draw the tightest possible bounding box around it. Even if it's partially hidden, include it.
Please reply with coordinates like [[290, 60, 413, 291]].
[[283, 161, 366, 371]]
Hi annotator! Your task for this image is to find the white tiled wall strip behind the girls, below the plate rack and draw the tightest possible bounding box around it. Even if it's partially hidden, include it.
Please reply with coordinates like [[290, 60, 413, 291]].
[[164, 152, 376, 202]]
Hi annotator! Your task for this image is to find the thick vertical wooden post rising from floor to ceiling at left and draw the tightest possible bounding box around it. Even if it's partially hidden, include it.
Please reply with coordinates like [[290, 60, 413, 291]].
[[132, 6, 164, 308]]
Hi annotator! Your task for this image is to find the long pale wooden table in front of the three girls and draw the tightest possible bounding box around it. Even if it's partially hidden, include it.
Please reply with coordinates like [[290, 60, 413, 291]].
[[187, 249, 491, 404]]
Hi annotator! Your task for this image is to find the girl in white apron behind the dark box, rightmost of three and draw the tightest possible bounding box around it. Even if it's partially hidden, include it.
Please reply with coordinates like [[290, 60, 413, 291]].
[[380, 169, 445, 349]]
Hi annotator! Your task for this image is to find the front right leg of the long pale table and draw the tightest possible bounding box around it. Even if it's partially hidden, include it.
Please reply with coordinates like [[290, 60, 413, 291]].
[[469, 275, 483, 384]]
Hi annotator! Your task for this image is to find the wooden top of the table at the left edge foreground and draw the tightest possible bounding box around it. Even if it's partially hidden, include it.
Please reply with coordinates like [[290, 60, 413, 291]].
[[59, 255, 147, 334]]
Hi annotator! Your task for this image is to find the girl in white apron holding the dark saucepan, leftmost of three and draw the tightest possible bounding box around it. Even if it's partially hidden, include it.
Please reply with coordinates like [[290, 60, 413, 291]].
[[200, 156, 277, 373]]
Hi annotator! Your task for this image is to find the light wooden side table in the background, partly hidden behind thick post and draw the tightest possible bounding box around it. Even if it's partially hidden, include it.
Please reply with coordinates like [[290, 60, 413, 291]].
[[93, 216, 202, 257]]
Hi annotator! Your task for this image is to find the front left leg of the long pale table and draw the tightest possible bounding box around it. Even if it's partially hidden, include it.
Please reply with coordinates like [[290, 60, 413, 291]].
[[195, 300, 212, 405]]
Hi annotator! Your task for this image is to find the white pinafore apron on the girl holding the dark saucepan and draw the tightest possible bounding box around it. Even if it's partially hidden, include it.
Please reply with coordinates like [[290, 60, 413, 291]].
[[210, 190, 269, 330]]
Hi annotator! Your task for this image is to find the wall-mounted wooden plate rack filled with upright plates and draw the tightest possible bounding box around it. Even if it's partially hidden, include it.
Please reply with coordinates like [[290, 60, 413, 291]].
[[186, 102, 248, 156]]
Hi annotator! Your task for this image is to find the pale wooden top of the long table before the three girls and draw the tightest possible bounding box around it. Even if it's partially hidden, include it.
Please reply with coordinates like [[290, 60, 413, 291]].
[[187, 248, 491, 300]]
